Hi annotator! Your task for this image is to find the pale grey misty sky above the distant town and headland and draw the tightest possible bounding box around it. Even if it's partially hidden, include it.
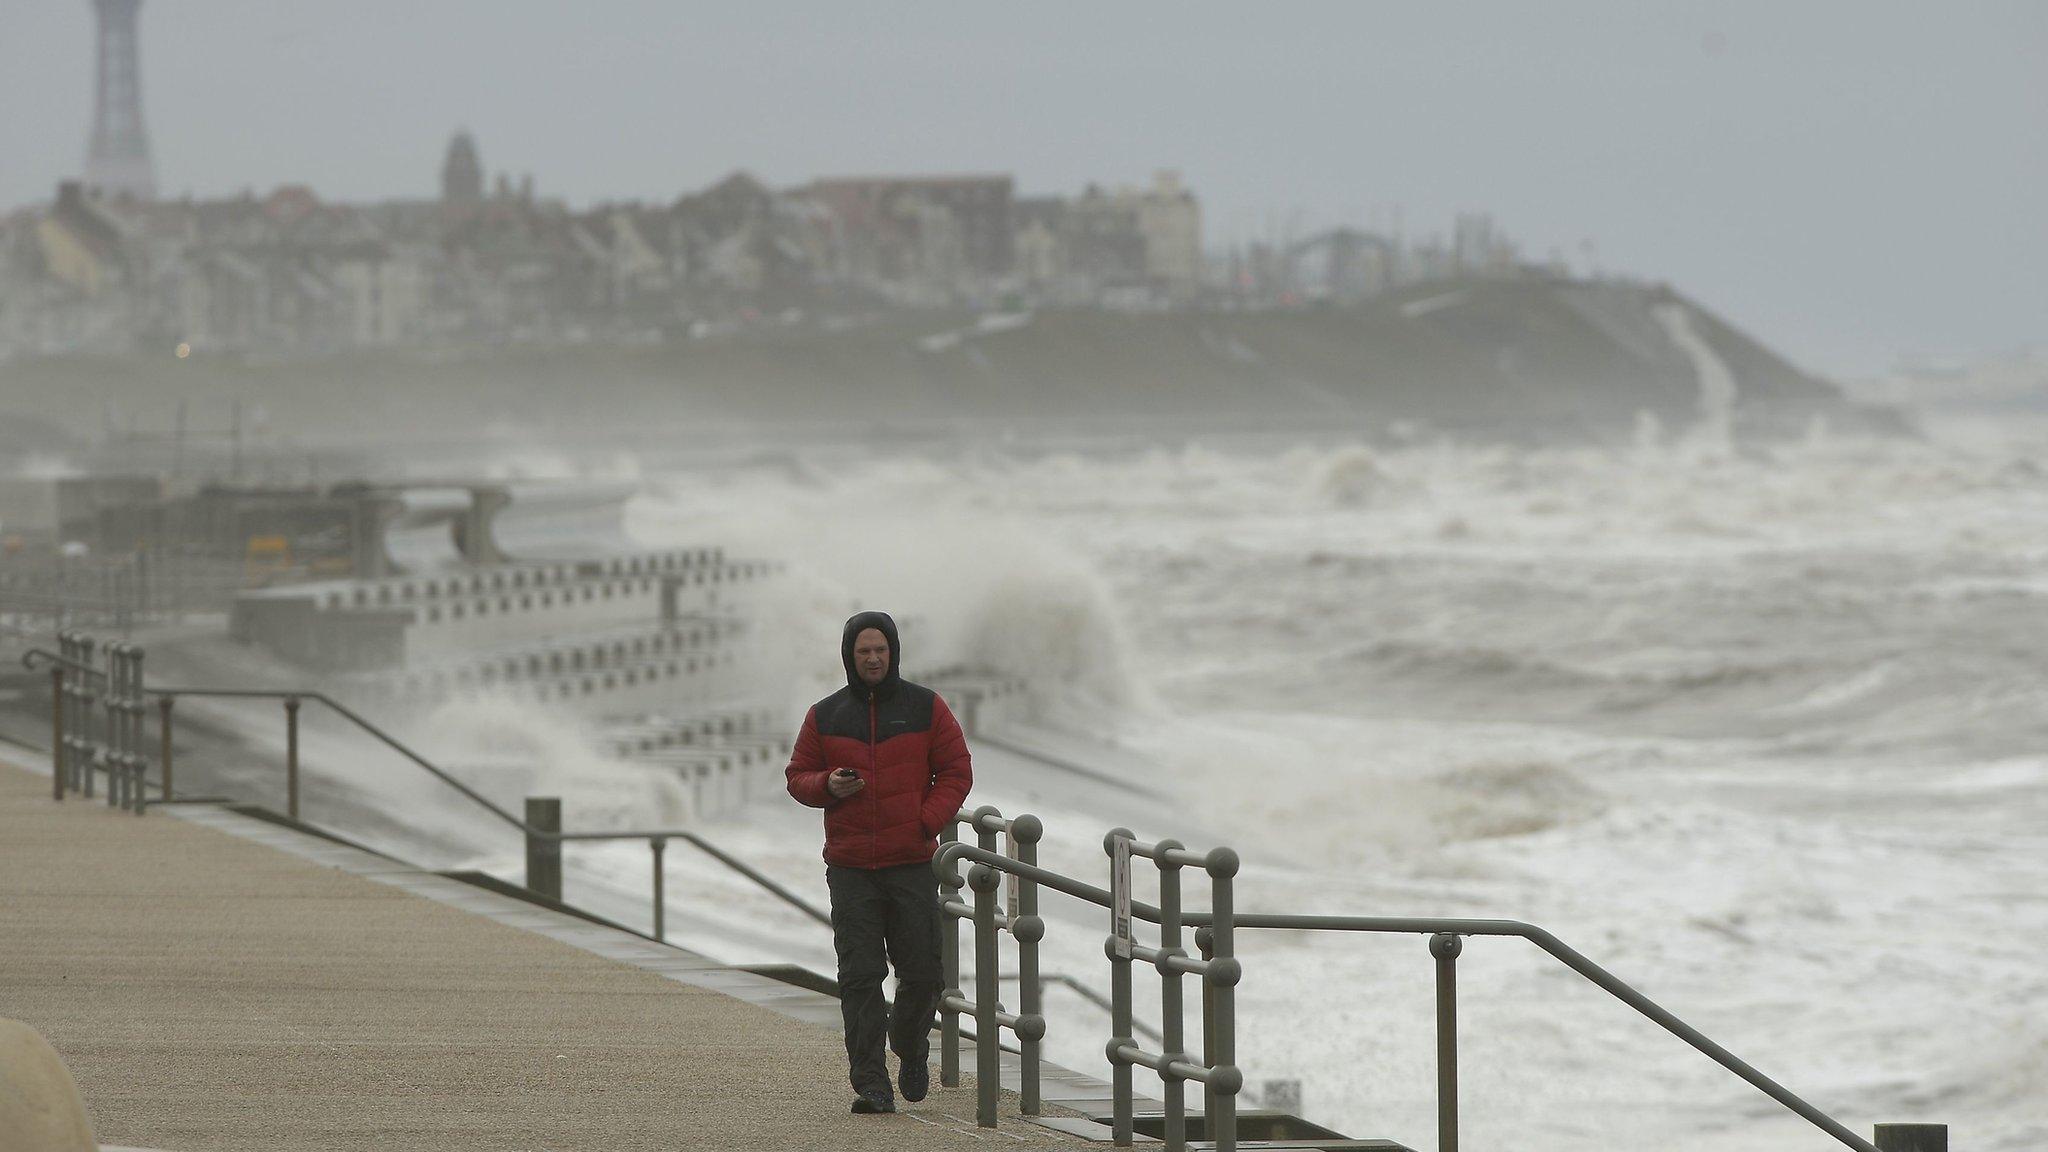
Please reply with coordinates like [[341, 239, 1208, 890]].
[[0, 0, 2048, 373]]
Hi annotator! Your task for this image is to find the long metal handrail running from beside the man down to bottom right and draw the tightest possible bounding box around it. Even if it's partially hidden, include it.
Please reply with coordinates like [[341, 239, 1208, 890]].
[[934, 842, 1878, 1152]]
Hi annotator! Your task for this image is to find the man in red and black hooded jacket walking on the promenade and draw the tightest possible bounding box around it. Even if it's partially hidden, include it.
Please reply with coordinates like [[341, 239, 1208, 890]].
[[784, 613, 975, 1113]]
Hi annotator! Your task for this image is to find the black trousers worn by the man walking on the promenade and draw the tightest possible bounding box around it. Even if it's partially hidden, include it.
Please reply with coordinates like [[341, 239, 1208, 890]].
[[825, 863, 944, 1097]]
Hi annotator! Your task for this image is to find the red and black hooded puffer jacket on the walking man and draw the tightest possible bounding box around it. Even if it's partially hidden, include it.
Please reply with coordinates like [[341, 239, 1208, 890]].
[[784, 613, 975, 867]]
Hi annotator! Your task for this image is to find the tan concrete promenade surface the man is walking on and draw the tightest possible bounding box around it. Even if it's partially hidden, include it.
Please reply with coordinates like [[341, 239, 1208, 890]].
[[0, 752, 1090, 1152]]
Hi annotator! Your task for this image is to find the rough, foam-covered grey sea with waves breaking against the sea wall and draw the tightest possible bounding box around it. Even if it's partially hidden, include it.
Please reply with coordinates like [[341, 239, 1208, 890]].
[[180, 407, 2048, 1152]]
